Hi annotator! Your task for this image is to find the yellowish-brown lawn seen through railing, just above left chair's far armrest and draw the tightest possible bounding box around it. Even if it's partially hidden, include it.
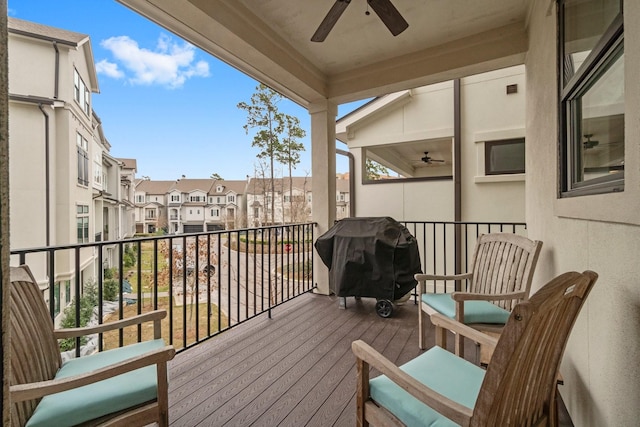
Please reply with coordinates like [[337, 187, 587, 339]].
[[103, 297, 228, 350]]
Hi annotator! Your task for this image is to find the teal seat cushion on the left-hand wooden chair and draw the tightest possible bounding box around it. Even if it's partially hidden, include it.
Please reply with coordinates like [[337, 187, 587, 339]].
[[26, 339, 165, 427]]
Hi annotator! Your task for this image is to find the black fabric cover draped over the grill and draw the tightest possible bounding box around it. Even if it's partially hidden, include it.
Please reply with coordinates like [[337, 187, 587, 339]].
[[315, 217, 422, 300]]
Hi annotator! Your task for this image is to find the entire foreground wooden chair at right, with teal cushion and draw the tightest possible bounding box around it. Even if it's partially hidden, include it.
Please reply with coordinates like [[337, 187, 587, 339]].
[[352, 271, 598, 426]]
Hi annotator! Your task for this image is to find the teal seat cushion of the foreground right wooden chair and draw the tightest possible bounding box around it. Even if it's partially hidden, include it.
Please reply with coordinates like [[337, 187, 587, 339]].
[[369, 347, 485, 427]]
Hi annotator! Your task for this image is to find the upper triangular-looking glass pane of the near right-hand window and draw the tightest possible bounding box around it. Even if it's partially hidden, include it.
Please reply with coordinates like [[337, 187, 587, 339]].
[[563, 0, 622, 84]]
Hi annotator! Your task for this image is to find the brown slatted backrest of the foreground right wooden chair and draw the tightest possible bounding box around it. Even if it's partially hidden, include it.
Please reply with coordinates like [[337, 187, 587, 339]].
[[471, 271, 597, 426]]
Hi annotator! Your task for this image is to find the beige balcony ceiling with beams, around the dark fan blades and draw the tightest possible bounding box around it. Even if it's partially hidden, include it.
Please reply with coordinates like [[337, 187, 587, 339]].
[[118, 0, 534, 107]]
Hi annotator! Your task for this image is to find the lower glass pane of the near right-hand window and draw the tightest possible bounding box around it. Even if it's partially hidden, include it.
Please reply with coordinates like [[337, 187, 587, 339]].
[[572, 48, 624, 184]]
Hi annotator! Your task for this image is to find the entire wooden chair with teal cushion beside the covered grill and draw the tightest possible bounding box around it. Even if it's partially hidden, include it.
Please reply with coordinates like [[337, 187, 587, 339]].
[[415, 233, 542, 356]]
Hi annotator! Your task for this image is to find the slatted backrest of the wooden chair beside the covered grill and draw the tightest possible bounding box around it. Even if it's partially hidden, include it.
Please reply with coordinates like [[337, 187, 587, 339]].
[[469, 233, 542, 311]]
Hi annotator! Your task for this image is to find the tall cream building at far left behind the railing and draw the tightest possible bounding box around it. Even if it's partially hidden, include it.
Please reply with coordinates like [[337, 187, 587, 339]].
[[8, 18, 135, 320]]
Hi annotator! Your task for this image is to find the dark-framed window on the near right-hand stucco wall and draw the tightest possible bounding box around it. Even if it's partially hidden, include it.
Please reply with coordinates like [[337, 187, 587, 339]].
[[558, 0, 625, 197]]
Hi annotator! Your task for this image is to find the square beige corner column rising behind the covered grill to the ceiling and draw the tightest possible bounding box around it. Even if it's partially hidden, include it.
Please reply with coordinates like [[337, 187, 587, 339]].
[[309, 100, 338, 295]]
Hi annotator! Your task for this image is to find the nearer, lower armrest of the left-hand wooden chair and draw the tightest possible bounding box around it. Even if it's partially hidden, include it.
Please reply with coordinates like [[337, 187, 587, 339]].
[[9, 345, 176, 402]]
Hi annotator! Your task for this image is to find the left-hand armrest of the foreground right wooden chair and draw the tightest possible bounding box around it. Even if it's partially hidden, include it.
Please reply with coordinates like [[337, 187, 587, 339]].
[[351, 340, 473, 425]]
